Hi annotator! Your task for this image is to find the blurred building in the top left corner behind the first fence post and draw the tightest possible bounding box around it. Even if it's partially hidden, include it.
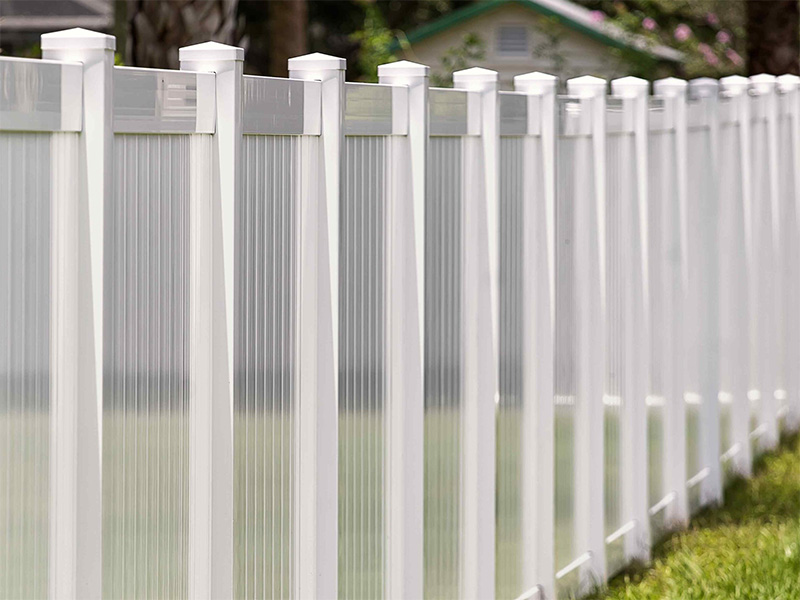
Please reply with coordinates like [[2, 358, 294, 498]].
[[0, 0, 114, 56]]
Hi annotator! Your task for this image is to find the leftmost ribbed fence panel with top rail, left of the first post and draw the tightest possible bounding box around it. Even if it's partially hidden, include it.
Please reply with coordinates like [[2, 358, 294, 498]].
[[0, 57, 83, 598]]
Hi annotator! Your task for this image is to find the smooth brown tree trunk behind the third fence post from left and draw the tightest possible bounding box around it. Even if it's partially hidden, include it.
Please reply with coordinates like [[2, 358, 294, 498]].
[[269, 0, 308, 77]]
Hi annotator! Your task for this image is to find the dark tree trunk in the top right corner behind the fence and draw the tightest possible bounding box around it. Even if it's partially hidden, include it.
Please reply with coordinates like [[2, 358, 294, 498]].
[[747, 0, 800, 75]]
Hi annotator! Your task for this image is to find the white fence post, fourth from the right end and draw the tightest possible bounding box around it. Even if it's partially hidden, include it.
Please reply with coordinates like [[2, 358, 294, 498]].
[[689, 77, 722, 505]]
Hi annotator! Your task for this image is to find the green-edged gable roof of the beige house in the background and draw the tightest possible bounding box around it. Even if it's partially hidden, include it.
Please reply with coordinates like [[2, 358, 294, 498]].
[[393, 0, 683, 62]]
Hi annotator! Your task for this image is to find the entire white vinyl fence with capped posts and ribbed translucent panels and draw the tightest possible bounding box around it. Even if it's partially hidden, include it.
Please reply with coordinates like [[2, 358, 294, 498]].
[[0, 30, 800, 600]]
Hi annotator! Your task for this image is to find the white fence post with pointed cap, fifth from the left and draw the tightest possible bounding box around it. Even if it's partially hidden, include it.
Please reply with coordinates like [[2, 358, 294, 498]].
[[453, 68, 499, 599]]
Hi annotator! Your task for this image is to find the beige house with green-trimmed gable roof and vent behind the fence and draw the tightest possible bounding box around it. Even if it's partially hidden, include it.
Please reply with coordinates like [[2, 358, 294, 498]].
[[394, 0, 683, 89]]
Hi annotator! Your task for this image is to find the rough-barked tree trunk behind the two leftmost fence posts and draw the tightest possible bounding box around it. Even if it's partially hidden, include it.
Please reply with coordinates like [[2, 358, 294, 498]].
[[126, 0, 239, 69]]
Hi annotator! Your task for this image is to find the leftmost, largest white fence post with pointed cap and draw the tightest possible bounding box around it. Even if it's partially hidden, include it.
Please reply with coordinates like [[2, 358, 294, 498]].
[[42, 29, 116, 598]]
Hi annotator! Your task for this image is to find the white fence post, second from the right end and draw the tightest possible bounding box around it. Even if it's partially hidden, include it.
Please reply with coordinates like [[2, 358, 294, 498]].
[[750, 74, 783, 450]]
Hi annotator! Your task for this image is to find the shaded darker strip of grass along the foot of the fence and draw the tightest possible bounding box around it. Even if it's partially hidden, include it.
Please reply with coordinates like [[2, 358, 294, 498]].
[[590, 434, 800, 600]]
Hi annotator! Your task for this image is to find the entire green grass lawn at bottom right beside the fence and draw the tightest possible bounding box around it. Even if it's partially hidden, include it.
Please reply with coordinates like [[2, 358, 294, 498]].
[[595, 436, 800, 600]]
